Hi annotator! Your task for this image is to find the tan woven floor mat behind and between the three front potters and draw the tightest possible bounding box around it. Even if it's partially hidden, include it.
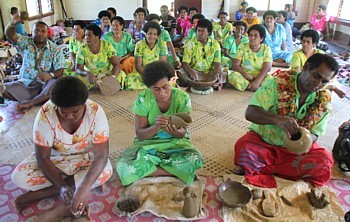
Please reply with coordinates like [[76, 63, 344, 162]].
[[0, 87, 350, 178]]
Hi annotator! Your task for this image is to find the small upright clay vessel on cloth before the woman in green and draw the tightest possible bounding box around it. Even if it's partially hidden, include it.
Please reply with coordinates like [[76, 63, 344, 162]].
[[182, 187, 199, 218]]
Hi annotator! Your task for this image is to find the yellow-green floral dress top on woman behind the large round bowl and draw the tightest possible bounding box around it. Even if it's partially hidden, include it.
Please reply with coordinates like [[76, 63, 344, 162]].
[[182, 38, 221, 73]]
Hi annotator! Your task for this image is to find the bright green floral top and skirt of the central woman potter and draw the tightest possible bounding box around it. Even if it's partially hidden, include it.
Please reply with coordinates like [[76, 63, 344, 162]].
[[116, 88, 204, 186]]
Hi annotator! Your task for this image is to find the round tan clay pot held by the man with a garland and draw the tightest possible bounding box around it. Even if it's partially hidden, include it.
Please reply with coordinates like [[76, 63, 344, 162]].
[[283, 127, 313, 154]]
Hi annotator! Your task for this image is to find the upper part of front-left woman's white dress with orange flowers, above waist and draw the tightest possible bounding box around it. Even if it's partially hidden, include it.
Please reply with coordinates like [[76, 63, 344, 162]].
[[33, 99, 109, 156]]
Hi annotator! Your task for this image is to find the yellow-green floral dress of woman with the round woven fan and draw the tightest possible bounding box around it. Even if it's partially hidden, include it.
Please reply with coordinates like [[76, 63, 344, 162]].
[[77, 40, 126, 89]]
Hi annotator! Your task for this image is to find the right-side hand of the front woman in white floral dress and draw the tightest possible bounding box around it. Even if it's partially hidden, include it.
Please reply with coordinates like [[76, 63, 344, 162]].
[[71, 185, 90, 217]]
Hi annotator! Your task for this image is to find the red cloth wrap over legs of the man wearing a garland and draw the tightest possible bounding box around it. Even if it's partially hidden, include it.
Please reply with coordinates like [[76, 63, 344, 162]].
[[234, 131, 334, 188]]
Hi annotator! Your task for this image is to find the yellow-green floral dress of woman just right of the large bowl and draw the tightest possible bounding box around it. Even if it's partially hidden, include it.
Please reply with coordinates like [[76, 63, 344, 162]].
[[227, 43, 272, 91]]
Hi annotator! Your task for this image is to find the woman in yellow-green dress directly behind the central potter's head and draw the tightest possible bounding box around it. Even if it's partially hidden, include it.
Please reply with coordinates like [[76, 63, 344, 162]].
[[125, 22, 168, 90]]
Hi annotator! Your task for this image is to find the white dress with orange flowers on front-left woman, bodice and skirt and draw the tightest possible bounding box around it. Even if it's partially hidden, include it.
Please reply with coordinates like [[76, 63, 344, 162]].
[[12, 99, 113, 191]]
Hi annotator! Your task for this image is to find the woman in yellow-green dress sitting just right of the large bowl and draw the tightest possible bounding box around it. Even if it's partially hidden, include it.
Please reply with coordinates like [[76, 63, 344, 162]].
[[227, 25, 272, 91]]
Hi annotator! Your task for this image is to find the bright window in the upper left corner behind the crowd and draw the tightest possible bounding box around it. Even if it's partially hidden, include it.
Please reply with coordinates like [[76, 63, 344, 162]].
[[26, 0, 53, 19]]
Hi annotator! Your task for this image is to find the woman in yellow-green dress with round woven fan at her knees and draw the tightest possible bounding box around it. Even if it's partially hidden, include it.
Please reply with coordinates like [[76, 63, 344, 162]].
[[76, 24, 125, 89]]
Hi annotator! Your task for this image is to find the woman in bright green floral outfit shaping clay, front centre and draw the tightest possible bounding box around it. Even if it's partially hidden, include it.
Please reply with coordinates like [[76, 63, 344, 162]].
[[116, 61, 203, 186]]
